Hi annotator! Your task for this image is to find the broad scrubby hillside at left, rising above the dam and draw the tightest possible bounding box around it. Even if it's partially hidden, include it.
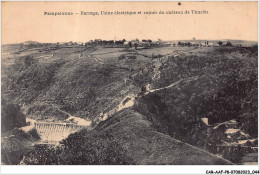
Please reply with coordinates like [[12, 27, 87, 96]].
[[2, 45, 139, 120]]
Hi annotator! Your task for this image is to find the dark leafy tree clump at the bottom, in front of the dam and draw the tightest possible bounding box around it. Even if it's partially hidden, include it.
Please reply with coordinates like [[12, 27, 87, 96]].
[[23, 129, 134, 165]]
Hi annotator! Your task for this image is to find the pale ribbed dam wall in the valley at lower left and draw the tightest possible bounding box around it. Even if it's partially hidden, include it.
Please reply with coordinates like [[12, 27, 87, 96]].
[[34, 122, 89, 143]]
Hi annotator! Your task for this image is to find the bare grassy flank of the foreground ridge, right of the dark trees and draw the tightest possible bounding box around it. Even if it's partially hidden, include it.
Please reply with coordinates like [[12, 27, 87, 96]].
[[96, 109, 230, 165]]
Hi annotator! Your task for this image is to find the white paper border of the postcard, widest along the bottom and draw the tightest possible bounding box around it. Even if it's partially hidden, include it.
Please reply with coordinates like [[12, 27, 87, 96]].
[[0, 0, 260, 175]]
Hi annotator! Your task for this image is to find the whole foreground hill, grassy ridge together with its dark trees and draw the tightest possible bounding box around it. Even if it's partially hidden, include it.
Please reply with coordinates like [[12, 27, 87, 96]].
[[23, 109, 232, 165]]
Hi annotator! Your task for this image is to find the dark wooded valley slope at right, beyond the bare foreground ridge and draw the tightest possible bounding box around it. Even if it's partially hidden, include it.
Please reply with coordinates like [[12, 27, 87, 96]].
[[149, 47, 257, 137]]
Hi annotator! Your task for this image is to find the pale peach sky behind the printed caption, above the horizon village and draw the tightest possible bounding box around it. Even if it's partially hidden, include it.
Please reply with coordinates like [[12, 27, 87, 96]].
[[1, 1, 258, 44]]
